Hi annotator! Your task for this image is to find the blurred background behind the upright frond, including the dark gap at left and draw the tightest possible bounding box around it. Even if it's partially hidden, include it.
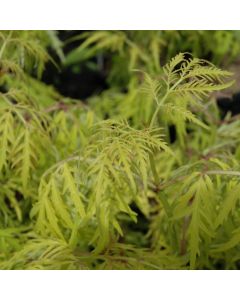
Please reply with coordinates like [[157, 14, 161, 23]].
[[44, 30, 240, 99]]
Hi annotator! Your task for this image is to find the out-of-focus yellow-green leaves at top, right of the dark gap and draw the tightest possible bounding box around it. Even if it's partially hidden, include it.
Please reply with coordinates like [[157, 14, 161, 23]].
[[65, 30, 240, 89]]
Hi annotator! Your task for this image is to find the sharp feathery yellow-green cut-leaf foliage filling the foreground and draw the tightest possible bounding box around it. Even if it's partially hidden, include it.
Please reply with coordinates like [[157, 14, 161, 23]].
[[0, 31, 240, 270]]
